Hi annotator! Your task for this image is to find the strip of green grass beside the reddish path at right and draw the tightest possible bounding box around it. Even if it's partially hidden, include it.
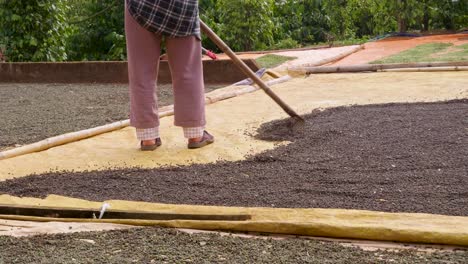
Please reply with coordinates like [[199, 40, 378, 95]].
[[371, 43, 468, 64]]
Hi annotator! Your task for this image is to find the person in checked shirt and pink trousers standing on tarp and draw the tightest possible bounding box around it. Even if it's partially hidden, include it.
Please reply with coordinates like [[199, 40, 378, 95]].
[[125, 0, 214, 151]]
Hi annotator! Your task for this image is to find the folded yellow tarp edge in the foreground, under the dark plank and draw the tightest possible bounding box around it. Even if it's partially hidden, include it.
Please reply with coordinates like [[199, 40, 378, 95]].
[[0, 195, 468, 246]]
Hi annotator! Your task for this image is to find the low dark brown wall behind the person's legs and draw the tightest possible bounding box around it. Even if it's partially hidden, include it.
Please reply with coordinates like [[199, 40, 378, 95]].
[[0, 59, 259, 83]]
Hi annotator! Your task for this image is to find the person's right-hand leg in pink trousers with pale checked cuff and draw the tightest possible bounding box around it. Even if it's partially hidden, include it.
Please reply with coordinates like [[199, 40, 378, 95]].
[[166, 36, 206, 141]]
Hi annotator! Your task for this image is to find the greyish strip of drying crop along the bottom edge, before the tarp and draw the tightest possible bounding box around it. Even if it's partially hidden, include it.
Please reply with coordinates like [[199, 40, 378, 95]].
[[0, 228, 468, 264]]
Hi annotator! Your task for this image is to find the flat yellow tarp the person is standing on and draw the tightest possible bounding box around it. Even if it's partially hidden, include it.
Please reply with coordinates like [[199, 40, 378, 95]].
[[0, 72, 468, 180]]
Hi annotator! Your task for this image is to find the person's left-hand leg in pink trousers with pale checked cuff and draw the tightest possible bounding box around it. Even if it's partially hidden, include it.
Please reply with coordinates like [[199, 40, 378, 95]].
[[125, 6, 161, 145]]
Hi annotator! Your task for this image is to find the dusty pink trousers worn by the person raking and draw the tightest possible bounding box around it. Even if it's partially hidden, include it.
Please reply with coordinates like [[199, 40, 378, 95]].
[[125, 7, 206, 129]]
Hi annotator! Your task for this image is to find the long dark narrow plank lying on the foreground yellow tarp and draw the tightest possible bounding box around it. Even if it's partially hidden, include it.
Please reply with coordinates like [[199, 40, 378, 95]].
[[0, 204, 251, 221]]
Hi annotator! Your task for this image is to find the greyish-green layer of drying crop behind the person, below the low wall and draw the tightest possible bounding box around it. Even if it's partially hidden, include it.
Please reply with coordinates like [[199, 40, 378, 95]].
[[0, 83, 224, 150]]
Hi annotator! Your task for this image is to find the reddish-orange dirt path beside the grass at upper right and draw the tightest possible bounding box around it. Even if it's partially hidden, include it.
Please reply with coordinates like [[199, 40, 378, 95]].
[[332, 34, 468, 66]]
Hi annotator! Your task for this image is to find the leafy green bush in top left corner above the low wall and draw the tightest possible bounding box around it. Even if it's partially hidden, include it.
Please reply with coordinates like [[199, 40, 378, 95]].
[[0, 0, 70, 61]]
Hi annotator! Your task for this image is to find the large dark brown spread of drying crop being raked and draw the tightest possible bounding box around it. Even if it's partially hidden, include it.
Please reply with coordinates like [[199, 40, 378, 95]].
[[0, 99, 468, 216]]
